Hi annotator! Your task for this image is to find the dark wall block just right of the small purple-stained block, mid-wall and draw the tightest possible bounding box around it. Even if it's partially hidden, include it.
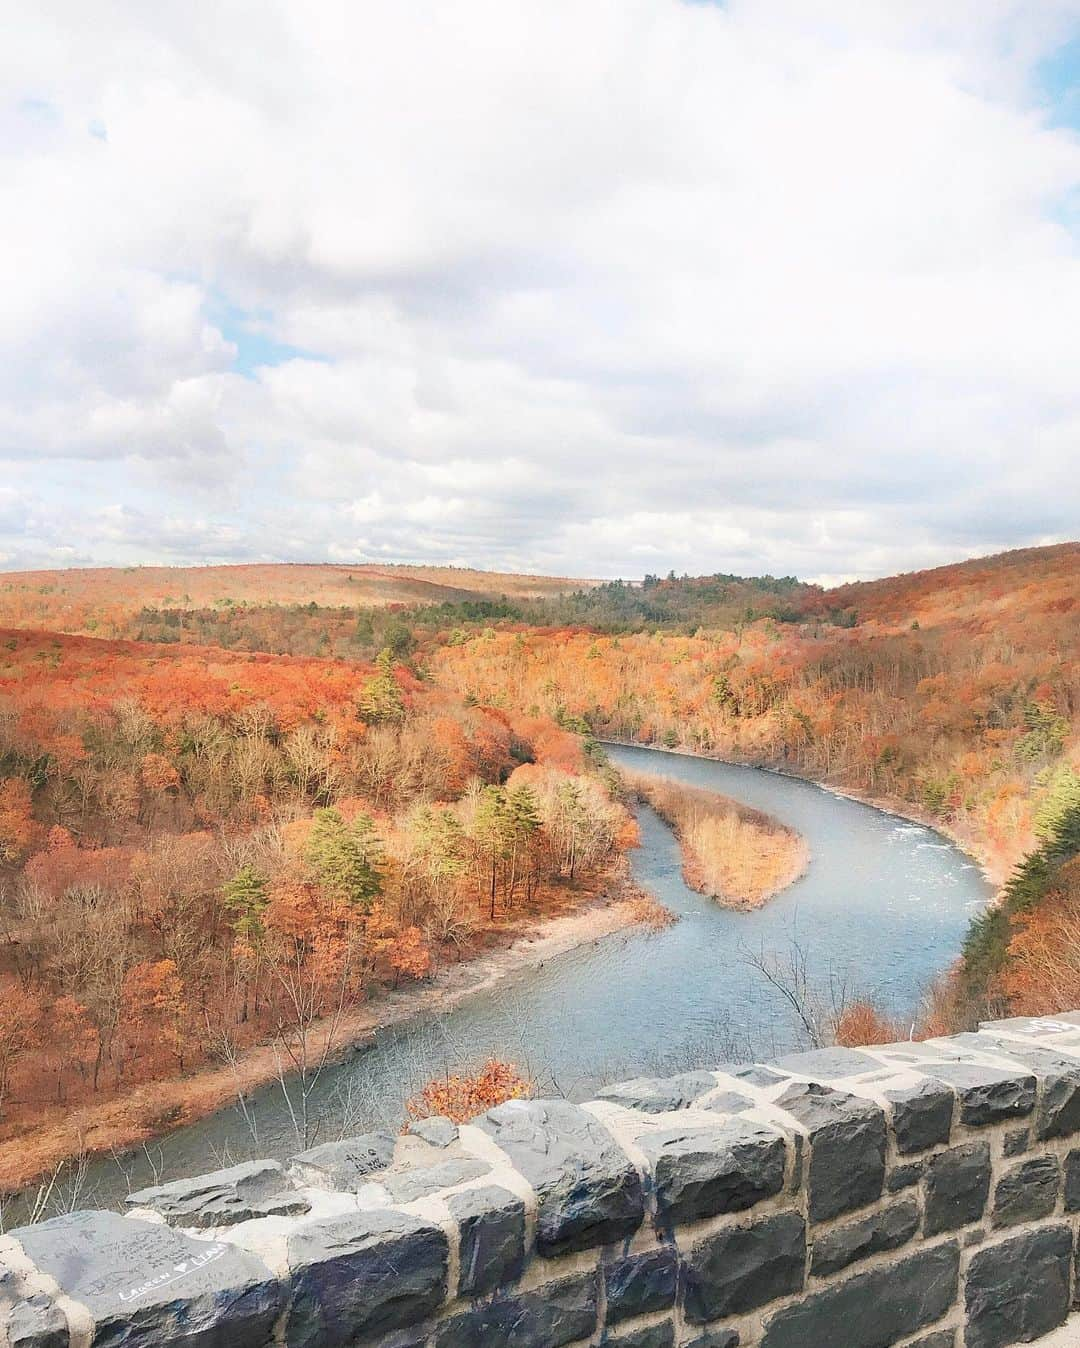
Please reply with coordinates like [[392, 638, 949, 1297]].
[[681, 1212, 806, 1325]]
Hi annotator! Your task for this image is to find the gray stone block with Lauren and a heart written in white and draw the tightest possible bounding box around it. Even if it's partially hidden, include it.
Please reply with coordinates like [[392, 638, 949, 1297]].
[[11, 1212, 280, 1348]]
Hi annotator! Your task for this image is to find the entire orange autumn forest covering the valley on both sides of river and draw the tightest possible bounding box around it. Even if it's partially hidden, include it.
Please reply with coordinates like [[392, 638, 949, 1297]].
[[0, 545, 1080, 1189]]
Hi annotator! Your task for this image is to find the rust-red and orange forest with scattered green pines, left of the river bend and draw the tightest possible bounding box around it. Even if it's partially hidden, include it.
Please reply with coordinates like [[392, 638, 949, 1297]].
[[0, 631, 635, 1175]]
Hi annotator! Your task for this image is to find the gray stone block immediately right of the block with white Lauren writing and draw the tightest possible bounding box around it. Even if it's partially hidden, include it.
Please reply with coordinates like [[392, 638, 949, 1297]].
[[286, 1209, 448, 1348]]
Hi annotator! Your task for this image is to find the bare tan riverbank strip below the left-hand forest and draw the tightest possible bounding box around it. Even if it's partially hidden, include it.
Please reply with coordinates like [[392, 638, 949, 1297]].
[[0, 868, 643, 1194]]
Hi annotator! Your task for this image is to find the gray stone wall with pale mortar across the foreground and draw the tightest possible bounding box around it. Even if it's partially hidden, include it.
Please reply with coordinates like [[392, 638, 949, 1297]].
[[0, 1014, 1080, 1348]]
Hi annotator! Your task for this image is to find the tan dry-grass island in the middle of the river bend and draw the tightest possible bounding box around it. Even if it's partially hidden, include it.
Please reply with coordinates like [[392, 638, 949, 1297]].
[[624, 772, 810, 909]]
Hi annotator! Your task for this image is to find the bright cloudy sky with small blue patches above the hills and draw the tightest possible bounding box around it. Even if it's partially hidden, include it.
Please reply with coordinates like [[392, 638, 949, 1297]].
[[0, 0, 1080, 582]]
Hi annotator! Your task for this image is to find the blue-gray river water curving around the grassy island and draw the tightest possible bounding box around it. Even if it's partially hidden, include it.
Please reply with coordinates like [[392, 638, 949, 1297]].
[[44, 745, 990, 1206]]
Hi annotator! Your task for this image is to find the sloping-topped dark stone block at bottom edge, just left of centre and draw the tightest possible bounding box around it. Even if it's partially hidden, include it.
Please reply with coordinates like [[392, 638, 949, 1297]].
[[431, 1274, 597, 1348]]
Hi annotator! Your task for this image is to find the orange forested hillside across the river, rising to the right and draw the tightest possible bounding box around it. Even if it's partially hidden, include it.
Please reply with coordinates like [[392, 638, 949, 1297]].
[[434, 545, 1080, 876]]
